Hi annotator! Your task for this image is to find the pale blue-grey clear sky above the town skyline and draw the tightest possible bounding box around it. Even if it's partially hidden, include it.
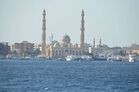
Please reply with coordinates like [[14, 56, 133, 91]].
[[0, 0, 139, 47]]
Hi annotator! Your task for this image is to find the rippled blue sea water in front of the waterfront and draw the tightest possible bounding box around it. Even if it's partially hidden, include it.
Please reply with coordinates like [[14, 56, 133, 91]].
[[0, 60, 139, 92]]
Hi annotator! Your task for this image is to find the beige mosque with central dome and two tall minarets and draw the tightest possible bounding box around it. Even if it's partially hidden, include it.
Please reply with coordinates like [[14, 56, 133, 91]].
[[41, 10, 85, 58]]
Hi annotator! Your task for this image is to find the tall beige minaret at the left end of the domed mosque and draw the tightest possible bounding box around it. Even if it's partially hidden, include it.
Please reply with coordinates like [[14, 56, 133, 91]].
[[41, 9, 46, 56]]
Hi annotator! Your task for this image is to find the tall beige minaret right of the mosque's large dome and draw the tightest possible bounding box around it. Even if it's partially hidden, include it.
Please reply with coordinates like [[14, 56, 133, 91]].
[[80, 10, 85, 48]]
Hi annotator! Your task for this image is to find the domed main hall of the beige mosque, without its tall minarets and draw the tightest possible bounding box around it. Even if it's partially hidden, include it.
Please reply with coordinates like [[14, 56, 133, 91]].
[[46, 35, 83, 58]]
